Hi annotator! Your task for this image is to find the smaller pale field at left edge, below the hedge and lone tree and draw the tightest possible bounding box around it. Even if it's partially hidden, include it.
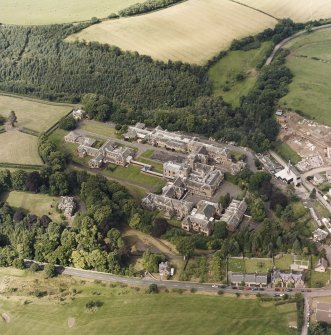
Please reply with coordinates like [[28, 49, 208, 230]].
[[0, 130, 42, 164]]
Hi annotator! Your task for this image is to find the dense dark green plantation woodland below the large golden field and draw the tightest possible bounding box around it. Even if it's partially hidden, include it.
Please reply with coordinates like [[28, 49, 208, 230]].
[[0, 24, 210, 110]]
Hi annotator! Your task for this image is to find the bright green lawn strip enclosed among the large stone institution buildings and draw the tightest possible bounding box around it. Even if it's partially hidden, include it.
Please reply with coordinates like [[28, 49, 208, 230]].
[[104, 164, 166, 191]]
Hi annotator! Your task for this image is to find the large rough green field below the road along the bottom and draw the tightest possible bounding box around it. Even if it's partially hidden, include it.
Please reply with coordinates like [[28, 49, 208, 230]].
[[0, 269, 295, 335]]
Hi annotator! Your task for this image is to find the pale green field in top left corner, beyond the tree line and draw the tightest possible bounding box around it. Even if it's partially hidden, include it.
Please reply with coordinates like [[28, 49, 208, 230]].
[[0, 0, 142, 25]]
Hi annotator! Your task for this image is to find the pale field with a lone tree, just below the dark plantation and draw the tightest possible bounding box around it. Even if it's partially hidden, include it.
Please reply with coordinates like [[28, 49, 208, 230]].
[[0, 95, 72, 132]]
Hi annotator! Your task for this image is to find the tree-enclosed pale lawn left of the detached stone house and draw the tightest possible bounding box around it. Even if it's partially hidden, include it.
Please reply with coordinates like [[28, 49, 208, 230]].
[[1, 191, 62, 221]]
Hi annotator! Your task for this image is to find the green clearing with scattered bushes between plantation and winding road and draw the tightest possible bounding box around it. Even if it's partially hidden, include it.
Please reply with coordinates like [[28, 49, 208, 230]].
[[208, 42, 271, 106]]
